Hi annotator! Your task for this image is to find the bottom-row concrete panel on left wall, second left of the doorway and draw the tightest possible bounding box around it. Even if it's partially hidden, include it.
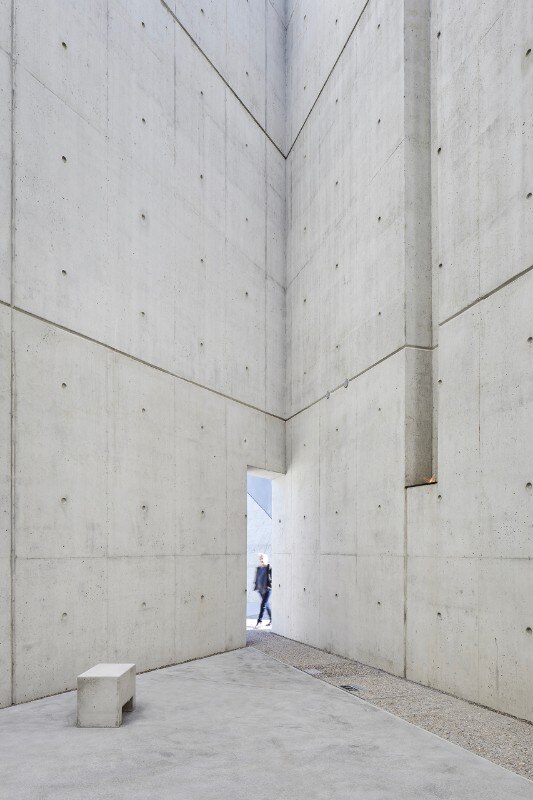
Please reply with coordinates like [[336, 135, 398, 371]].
[[175, 556, 225, 661]]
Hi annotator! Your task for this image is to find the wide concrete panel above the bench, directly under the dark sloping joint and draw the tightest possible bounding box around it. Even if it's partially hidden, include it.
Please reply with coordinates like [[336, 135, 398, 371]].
[[13, 312, 110, 560]]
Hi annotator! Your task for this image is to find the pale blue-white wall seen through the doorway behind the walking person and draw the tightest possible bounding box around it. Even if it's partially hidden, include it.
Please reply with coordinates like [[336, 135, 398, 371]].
[[246, 475, 272, 617]]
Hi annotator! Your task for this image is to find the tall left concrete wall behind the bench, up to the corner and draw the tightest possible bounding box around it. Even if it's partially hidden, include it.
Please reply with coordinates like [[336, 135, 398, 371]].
[[0, 0, 285, 705]]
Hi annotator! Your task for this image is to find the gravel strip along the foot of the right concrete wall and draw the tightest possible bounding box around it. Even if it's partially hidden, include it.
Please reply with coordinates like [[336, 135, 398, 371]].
[[247, 630, 533, 780]]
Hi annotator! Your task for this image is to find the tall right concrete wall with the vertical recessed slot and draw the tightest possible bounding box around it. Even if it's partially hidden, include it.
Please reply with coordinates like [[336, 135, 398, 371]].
[[273, 0, 533, 720]]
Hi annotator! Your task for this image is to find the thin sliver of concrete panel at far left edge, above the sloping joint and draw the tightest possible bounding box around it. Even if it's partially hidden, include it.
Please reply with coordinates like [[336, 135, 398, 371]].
[[0, 48, 11, 303]]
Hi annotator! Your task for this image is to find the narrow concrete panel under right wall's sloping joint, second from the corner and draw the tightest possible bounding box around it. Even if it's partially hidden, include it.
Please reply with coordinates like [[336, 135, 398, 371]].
[[318, 382, 358, 556]]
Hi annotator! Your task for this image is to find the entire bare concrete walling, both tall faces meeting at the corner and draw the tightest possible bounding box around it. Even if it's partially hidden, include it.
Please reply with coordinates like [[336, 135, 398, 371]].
[[0, 0, 533, 720]]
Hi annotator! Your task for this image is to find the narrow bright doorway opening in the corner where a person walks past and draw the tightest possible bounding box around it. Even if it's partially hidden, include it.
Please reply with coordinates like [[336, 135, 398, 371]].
[[246, 470, 272, 631]]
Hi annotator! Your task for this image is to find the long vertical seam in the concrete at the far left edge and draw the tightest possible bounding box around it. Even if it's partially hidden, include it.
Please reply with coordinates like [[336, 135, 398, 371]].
[[9, 0, 16, 703]]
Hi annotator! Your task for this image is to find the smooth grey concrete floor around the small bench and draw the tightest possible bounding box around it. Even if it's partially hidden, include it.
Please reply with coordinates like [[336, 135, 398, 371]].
[[0, 648, 533, 800]]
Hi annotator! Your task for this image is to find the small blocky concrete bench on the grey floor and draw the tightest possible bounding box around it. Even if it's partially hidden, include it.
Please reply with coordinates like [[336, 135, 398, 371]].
[[77, 664, 135, 728]]
